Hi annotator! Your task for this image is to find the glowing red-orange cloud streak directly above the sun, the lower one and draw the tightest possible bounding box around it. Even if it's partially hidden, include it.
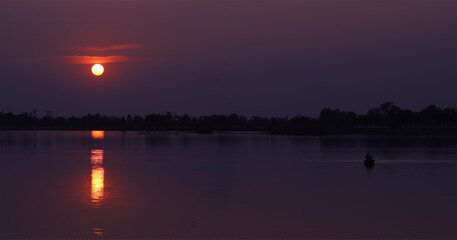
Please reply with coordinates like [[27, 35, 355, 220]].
[[57, 55, 142, 64]]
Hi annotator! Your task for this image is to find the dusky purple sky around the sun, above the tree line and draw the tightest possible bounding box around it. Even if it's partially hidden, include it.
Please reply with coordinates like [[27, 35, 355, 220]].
[[0, 0, 457, 117]]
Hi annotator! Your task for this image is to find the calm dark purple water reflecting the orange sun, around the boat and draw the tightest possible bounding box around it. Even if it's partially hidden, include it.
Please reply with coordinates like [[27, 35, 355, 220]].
[[0, 131, 457, 238]]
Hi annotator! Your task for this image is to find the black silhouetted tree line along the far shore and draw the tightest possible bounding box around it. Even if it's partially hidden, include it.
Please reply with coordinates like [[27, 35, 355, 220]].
[[0, 102, 457, 134]]
